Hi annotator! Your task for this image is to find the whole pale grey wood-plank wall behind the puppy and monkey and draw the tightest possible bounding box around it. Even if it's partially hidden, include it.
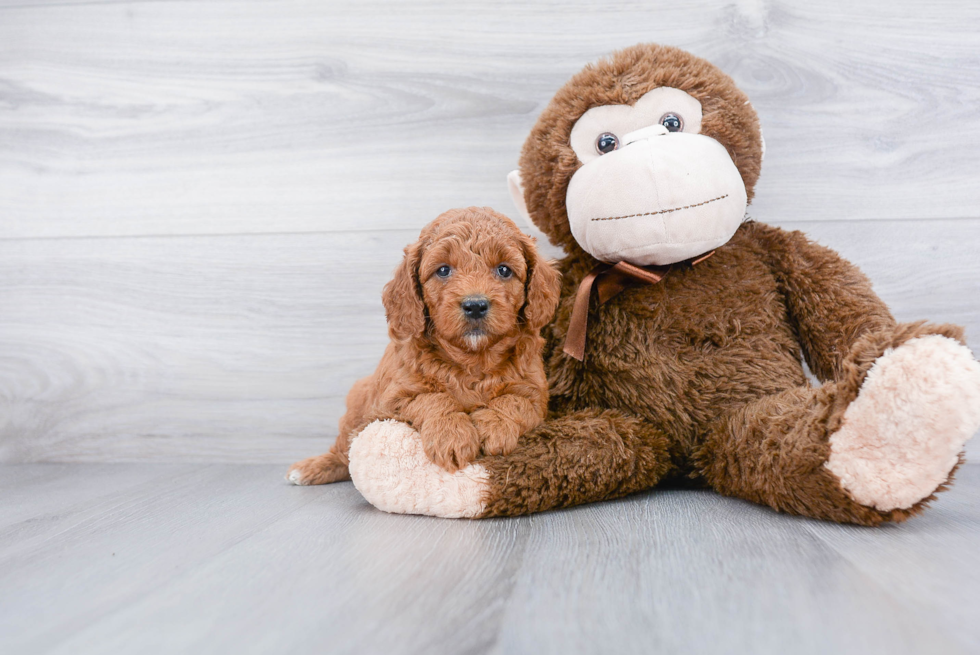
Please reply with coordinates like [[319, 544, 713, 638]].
[[0, 0, 980, 463]]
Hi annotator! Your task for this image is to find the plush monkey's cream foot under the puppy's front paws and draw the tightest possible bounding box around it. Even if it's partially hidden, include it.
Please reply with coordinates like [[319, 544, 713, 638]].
[[349, 420, 489, 518]]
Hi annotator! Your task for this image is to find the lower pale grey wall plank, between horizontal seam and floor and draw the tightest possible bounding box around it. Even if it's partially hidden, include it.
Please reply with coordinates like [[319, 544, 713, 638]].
[[0, 220, 980, 463]]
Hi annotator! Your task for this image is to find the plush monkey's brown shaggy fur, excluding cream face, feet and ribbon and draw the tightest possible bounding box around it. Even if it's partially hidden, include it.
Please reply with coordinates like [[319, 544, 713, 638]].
[[470, 45, 962, 525]]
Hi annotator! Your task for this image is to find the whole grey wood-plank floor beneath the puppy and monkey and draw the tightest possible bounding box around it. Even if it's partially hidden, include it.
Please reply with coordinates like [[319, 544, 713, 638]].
[[0, 463, 980, 655]]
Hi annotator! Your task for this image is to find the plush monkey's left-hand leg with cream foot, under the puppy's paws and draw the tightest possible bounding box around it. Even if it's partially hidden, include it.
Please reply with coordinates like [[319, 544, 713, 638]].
[[350, 410, 671, 518]]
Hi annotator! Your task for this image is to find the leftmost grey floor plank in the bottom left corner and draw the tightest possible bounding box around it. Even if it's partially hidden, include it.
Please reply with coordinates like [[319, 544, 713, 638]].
[[0, 466, 326, 653]]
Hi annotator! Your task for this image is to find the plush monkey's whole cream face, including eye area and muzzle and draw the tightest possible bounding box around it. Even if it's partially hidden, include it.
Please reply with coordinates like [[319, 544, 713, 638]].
[[565, 87, 746, 266]]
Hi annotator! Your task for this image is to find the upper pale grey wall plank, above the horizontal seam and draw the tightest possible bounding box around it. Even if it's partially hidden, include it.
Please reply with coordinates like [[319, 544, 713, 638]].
[[0, 0, 980, 238]]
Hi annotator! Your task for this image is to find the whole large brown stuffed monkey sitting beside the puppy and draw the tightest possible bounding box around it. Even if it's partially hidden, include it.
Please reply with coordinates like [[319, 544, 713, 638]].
[[350, 45, 980, 525]]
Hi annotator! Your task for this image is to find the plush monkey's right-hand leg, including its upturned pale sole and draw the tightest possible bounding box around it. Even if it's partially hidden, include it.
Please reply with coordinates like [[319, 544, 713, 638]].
[[697, 335, 980, 525]]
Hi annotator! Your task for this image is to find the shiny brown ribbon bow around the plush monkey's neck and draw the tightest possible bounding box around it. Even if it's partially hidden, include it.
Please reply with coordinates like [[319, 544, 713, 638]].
[[564, 250, 715, 362]]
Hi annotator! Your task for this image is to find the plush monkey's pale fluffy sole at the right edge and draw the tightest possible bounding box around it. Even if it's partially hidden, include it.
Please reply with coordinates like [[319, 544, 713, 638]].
[[825, 335, 980, 512]]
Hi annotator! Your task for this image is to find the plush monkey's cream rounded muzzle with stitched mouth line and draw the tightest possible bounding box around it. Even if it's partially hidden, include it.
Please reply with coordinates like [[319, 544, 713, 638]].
[[565, 132, 746, 266]]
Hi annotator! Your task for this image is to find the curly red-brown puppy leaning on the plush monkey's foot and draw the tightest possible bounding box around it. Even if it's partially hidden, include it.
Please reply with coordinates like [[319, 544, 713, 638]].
[[287, 207, 560, 485]]
